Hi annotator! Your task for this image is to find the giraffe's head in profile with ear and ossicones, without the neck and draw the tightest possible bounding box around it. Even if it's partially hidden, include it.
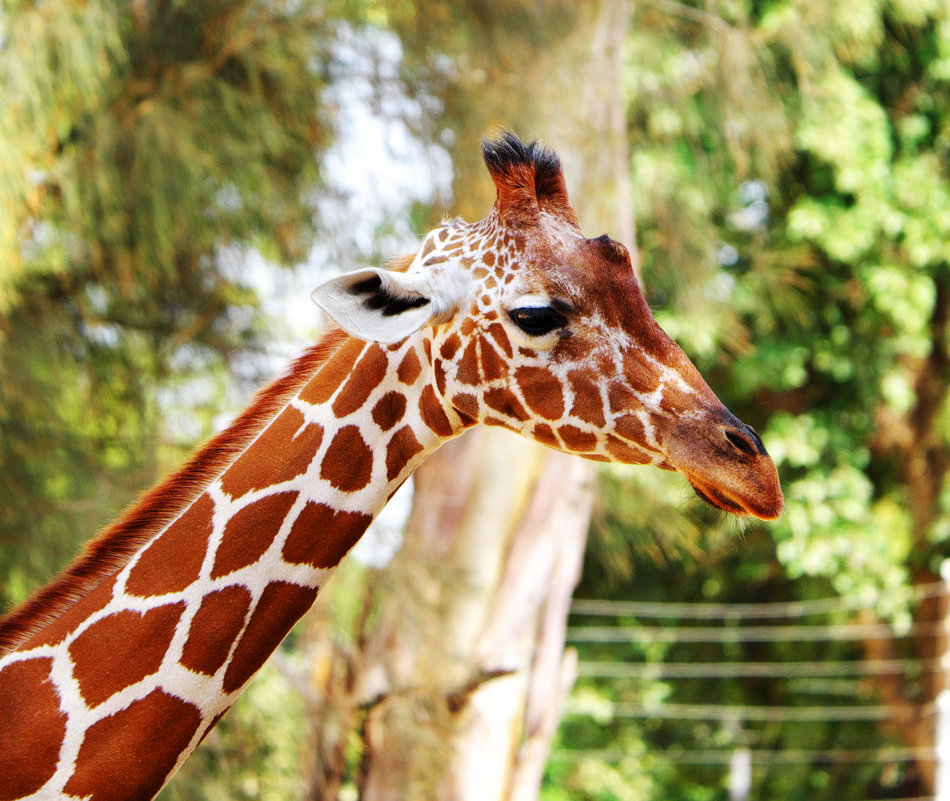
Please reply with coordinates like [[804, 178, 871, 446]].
[[313, 134, 783, 519]]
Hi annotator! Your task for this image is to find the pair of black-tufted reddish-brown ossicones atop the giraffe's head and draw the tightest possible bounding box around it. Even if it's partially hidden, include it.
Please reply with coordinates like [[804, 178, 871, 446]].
[[482, 131, 580, 230]]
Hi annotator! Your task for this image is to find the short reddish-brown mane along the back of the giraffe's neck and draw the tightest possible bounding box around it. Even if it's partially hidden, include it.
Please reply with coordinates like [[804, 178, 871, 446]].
[[0, 329, 346, 656]]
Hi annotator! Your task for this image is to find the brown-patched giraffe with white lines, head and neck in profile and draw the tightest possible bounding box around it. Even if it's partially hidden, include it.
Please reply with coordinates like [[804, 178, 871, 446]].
[[0, 133, 783, 801]]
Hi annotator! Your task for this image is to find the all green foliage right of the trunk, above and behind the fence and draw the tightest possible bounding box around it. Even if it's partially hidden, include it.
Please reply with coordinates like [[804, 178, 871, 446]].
[[549, 0, 950, 799]]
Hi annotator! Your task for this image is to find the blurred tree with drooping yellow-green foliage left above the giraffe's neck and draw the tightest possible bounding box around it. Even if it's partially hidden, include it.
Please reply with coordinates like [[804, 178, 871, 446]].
[[0, 0, 332, 607]]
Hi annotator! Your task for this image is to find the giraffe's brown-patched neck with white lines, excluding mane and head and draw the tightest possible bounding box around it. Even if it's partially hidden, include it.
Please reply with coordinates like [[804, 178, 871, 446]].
[[0, 330, 466, 799]]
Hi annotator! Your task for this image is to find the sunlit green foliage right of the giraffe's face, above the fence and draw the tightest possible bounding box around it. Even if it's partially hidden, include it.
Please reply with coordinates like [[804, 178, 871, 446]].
[[608, 0, 950, 615]]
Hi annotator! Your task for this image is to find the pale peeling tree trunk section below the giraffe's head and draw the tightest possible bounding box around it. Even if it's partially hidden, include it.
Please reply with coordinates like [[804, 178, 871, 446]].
[[361, 430, 592, 801]]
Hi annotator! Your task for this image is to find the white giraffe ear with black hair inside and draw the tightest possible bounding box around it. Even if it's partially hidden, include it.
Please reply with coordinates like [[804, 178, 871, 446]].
[[310, 268, 458, 345]]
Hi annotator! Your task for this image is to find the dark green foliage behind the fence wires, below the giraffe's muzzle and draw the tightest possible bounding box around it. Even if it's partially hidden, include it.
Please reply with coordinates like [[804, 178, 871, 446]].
[[556, 520, 914, 801]]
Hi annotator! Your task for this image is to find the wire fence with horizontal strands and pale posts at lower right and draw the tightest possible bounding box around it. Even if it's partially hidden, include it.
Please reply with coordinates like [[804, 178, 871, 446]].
[[551, 581, 950, 801]]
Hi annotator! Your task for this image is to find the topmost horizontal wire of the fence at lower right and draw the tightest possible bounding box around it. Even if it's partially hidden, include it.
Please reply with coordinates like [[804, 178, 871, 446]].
[[571, 581, 947, 620]]
